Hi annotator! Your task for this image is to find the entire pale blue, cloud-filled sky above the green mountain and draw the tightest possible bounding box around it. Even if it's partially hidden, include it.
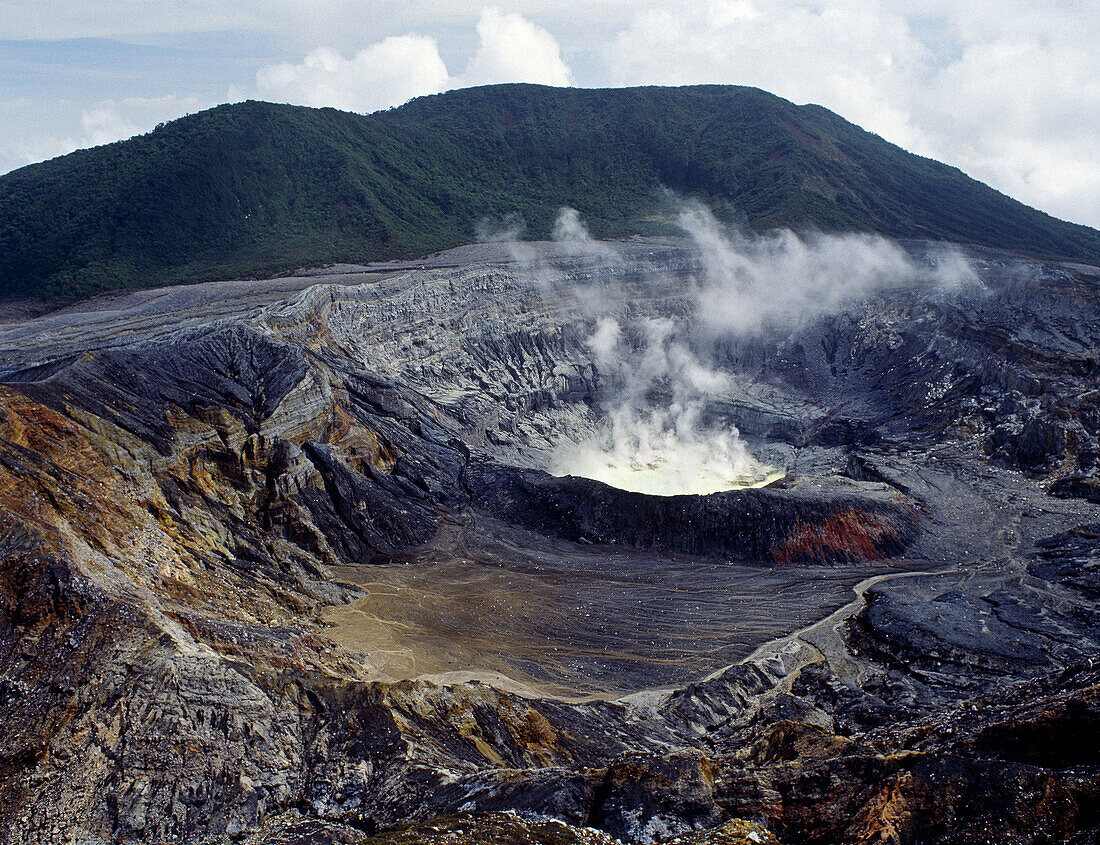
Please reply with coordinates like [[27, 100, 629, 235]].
[[0, 0, 1100, 227]]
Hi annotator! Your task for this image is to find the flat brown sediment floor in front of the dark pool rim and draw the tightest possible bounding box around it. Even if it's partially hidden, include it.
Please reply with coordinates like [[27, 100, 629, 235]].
[[325, 550, 919, 698]]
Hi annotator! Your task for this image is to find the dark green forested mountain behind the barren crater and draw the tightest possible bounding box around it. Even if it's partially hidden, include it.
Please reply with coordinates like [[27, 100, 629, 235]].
[[0, 85, 1100, 299]]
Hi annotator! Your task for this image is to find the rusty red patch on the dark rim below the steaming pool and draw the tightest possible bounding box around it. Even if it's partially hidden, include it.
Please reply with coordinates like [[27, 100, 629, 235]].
[[772, 507, 904, 563]]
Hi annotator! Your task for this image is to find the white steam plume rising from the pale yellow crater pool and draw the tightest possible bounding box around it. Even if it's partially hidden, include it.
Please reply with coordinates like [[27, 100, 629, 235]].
[[495, 201, 976, 494]]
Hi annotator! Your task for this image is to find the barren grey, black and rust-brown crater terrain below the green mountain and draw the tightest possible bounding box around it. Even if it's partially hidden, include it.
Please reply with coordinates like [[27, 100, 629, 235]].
[[0, 241, 1100, 844]]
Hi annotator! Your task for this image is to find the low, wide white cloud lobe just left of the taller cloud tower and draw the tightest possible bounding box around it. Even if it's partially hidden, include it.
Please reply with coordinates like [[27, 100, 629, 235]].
[[256, 34, 450, 111]]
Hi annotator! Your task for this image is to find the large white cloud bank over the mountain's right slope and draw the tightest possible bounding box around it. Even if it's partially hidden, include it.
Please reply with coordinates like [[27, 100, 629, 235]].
[[604, 0, 1100, 226]]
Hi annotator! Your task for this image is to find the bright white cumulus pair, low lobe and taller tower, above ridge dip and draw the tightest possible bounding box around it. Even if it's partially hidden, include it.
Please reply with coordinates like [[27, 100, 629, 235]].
[[255, 8, 572, 112]]
